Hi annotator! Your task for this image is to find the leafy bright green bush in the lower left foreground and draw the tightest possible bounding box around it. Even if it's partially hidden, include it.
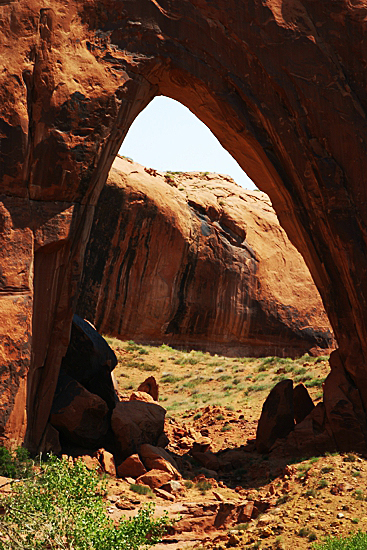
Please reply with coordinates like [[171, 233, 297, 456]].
[[0, 457, 170, 550]]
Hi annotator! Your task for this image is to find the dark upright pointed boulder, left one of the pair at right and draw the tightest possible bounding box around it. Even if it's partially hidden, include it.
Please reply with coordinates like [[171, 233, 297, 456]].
[[256, 380, 294, 453]]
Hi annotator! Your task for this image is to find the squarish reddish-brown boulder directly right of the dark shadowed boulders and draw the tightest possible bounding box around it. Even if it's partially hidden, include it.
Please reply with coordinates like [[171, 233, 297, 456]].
[[111, 401, 166, 459]]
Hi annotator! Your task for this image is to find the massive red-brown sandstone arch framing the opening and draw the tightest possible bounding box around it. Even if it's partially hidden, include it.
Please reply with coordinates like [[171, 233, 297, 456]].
[[0, 0, 367, 449]]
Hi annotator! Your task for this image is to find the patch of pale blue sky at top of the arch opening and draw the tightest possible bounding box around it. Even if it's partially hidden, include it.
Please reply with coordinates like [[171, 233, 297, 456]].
[[120, 96, 255, 189]]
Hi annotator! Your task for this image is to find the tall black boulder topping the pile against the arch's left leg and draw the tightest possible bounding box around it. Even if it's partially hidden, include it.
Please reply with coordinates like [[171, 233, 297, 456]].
[[61, 315, 118, 409]]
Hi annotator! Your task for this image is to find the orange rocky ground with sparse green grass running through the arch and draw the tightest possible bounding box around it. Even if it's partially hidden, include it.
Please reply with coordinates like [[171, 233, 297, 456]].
[[98, 339, 367, 550]]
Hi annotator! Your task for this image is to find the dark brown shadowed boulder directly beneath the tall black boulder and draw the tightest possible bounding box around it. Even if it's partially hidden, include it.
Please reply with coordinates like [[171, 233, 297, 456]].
[[50, 373, 109, 448]]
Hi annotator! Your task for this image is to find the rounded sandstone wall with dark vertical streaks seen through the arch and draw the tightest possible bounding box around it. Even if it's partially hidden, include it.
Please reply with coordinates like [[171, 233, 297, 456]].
[[77, 158, 333, 356]]
